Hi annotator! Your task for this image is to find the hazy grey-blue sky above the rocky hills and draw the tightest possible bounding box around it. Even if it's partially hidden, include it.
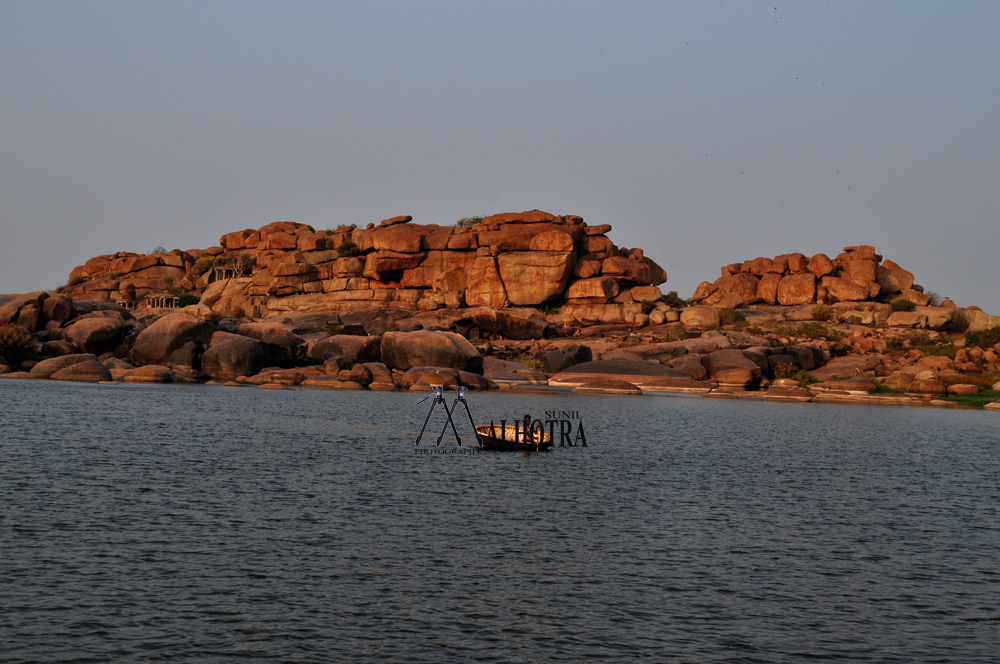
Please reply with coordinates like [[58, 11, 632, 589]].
[[0, 0, 1000, 314]]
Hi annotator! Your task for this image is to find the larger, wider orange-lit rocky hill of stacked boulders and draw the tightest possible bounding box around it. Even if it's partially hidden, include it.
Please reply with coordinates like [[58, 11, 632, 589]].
[[65, 210, 667, 334]]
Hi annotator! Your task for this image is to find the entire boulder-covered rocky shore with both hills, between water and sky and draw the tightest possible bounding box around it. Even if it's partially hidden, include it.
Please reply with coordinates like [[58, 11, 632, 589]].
[[0, 210, 1000, 410]]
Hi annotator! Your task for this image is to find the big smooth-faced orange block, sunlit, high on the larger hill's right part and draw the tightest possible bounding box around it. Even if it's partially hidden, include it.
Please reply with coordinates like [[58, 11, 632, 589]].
[[497, 251, 576, 306]]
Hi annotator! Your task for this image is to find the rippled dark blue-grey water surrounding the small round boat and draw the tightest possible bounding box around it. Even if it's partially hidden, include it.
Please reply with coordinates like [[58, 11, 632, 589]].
[[0, 381, 1000, 662]]
